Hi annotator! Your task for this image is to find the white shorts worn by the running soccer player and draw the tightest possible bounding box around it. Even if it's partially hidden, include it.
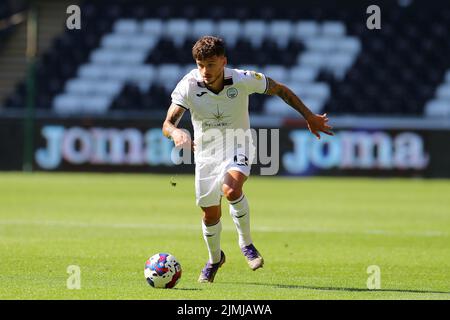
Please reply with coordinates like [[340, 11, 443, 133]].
[[195, 154, 251, 207]]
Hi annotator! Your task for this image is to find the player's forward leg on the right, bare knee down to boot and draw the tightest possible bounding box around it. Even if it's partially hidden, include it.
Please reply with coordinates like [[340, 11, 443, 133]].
[[222, 169, 264, 270]]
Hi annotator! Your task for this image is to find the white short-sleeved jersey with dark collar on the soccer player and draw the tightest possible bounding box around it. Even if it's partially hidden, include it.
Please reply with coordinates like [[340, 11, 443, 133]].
[[172, 68, 268, 162]]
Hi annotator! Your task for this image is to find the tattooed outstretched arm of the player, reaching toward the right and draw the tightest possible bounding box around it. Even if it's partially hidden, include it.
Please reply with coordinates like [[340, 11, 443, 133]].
[[266, 77, 334, 139]]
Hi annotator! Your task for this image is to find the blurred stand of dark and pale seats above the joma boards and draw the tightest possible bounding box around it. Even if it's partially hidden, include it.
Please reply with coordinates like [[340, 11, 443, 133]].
[[5, 1, 450, 117]]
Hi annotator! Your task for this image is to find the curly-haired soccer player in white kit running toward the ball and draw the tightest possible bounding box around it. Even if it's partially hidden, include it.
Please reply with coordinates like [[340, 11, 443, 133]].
[[163, 36, 333, 282]]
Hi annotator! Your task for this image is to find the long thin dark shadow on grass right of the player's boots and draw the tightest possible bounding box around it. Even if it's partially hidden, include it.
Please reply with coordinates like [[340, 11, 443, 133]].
[[227, 282, 450, 294]]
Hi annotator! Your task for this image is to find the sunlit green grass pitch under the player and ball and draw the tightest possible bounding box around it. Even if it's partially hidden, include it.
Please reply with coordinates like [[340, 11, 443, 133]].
[[0, 173, 450, 300]]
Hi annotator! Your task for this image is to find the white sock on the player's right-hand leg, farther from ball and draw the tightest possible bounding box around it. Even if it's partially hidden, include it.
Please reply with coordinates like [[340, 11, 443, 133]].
[[230, 194, 252, 248]]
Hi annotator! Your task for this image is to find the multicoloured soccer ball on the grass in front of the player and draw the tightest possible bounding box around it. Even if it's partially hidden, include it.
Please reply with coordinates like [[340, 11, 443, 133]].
[[144, 253, 181, 288]]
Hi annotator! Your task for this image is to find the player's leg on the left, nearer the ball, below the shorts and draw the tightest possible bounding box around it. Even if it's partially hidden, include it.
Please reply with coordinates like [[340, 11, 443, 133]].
[[198, 205, 225, 282]]
